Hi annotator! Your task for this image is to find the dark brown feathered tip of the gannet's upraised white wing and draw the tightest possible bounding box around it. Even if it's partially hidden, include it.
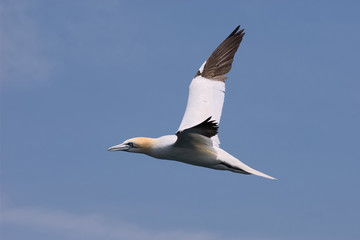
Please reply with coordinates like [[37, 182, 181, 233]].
[[195, 26, 245, 82]]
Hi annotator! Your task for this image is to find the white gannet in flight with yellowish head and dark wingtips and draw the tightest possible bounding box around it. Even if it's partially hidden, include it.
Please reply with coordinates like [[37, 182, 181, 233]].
[[108, 26, 274, 179]]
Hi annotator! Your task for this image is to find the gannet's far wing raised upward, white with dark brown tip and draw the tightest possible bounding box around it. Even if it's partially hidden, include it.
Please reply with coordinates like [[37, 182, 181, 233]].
[[179, 26, 245, 145]]
